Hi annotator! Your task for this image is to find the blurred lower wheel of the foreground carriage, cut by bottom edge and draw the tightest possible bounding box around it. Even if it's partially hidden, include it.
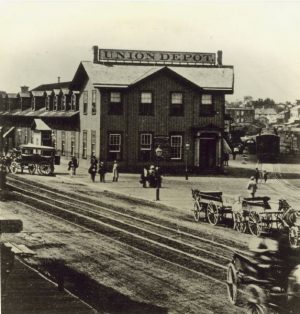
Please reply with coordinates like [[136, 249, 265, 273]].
[[245, 284, 267, 314]]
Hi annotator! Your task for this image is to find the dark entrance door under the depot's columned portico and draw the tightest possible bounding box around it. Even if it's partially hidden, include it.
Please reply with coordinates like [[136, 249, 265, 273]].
[[199, 137, 217, 170]]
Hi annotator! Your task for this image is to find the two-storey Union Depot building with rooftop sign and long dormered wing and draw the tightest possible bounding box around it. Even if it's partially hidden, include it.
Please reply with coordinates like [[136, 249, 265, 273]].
[[0, 46, 234, 173]]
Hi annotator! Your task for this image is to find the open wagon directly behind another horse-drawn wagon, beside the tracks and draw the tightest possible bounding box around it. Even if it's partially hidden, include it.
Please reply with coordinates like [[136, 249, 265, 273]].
[[192, 189, 232, 225]]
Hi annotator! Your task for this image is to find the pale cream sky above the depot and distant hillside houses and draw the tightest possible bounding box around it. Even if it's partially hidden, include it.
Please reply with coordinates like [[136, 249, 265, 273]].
[[0, 0, 300, 102]]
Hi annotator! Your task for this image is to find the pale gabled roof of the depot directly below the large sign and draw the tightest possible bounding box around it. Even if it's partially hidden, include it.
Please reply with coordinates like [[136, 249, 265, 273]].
[[75, 61, 234, 92]]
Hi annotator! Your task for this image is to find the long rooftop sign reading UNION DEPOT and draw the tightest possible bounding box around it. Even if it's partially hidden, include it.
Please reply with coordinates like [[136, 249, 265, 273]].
[[94, 47, 216, 65]]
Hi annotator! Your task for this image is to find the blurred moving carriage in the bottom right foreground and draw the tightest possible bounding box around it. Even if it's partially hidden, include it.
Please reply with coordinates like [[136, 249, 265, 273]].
[[227, 246, 300, 314]]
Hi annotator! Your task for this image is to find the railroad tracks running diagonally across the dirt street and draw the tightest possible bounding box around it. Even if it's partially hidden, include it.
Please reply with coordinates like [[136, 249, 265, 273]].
[[7, 176, 251, 283]]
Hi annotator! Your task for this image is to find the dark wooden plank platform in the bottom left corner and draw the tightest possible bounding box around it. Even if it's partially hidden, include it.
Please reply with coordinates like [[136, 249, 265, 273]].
[[1, 258, 98, 314]]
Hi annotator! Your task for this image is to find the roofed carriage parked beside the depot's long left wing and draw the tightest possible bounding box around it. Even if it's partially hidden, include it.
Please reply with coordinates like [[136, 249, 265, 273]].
[[10, 144, 60, 175]]
